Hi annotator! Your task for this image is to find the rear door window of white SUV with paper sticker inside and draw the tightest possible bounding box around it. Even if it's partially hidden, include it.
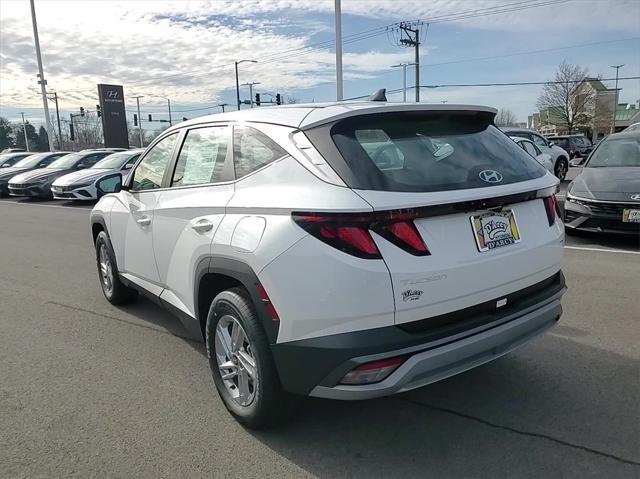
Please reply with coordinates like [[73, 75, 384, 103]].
[[171, 126, 228, 186]]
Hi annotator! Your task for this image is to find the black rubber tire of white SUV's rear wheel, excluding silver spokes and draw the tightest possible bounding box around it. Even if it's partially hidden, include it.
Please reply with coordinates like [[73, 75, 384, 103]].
[[205, 288, 299, 429]]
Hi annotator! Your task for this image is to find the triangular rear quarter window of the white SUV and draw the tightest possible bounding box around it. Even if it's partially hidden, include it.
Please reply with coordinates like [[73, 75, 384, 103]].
[[233, 126, 287, 178]]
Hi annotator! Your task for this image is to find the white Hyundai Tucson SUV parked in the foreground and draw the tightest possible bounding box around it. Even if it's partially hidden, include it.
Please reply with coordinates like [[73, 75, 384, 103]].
[[91, 102, 566, 428]]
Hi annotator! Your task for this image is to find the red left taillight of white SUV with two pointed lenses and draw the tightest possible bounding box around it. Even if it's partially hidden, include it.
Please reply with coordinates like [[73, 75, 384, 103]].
[[292, 210, 431, 259]]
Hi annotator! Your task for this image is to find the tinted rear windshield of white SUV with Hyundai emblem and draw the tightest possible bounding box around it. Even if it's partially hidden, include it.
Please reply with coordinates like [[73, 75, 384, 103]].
[[318, 112, 546, 192]]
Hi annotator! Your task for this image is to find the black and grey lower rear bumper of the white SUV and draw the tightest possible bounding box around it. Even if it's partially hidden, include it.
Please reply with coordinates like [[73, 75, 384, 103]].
[[273, 273, 566, 400]]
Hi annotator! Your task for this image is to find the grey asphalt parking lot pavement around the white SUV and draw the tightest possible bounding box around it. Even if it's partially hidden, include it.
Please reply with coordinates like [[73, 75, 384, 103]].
[[0, 183, 640, 478]]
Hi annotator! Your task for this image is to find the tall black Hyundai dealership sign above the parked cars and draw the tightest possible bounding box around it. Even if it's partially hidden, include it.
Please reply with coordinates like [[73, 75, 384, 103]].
[[98, 84, 129, 148]]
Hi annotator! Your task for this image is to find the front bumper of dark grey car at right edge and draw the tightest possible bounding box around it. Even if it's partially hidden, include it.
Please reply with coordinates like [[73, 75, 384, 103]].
[[564, 201, 640, 235]]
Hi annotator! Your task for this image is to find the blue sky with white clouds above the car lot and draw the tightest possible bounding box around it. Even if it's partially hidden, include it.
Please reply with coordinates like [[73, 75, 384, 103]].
[[0, 0, 640, 129]]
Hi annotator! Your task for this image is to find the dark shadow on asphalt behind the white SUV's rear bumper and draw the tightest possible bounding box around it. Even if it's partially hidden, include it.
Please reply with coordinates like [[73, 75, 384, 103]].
[[253, 335, 640, 478]]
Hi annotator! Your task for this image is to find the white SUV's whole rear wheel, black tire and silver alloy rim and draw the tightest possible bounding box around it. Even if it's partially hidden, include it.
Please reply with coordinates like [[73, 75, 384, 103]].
[[206, 288, 296, 429]]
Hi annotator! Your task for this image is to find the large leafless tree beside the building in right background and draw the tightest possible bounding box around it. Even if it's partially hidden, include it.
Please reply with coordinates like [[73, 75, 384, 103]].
[[537, 61, 595, 132]]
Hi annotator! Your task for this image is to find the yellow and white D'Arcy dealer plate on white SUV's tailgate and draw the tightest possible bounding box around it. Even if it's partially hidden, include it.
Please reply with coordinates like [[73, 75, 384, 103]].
[[469, 210, 520, 252]]
